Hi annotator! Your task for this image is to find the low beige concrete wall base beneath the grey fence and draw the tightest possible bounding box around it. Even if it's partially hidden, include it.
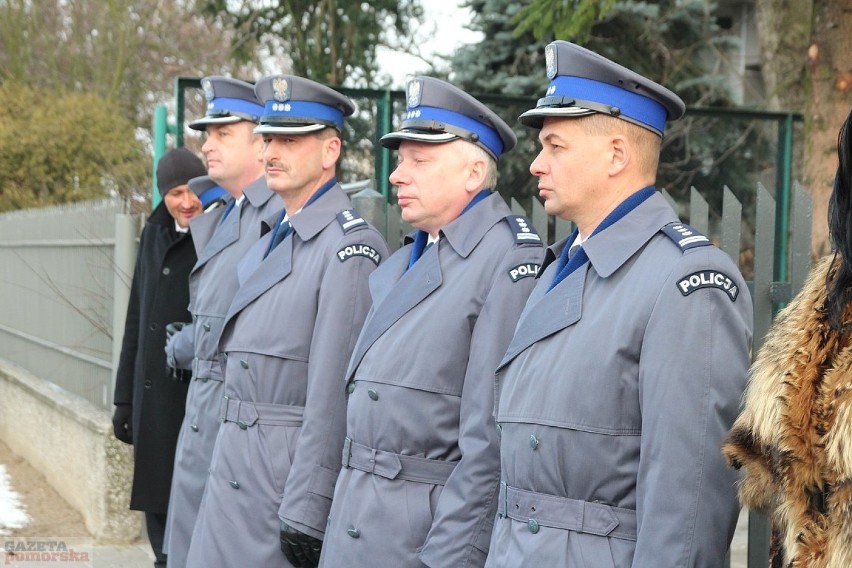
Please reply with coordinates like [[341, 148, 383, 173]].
[[0, 359, 141, 544]]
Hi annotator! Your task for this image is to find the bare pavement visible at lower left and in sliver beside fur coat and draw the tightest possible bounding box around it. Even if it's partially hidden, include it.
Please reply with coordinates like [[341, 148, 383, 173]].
[[0, 432, 748, 568]]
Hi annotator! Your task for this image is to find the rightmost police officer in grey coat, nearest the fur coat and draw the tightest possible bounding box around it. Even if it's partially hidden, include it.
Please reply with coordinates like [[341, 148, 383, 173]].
[[487, 41, 752, 567]]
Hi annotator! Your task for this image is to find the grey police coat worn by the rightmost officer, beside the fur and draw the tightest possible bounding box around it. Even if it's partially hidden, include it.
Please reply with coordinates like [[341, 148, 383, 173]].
[[487, 194, 752, 568]]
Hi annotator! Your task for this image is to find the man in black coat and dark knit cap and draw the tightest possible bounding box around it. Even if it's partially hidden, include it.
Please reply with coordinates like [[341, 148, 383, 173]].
[[112, 148, 206, 566]]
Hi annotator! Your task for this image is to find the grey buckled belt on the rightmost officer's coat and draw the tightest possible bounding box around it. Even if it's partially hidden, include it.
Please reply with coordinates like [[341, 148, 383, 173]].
[[497, 481, 636, 541]]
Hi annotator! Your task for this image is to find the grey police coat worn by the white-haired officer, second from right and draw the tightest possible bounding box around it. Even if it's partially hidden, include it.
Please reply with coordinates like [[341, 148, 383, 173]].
[[320, 194, 544, 568]]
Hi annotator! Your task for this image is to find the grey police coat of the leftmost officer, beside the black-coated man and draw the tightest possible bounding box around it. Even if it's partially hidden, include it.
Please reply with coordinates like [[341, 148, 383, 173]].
[[163, 178, 282, 567]]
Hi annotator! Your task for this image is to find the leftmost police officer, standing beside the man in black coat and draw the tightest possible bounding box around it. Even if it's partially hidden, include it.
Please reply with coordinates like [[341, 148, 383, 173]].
[[160, 77, 281, 567]]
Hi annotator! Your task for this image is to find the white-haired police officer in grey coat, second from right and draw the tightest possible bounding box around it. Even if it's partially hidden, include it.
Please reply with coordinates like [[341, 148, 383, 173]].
[[321, 77, 543, 568]]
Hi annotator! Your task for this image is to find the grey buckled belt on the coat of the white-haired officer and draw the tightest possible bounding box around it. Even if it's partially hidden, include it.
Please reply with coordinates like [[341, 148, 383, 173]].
[[343, 436, 458, 485]]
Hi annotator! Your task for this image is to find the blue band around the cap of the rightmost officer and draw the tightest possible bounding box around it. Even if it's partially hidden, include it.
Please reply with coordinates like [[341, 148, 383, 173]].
[[547, 75, 668, 132]]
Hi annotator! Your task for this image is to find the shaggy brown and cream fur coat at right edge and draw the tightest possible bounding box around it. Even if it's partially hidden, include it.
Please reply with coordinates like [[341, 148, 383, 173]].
[[723, 256, 852, 568]]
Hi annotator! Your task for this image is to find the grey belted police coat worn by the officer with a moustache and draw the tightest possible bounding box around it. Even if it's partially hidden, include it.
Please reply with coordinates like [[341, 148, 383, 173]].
[[188, 185, 388, 568]]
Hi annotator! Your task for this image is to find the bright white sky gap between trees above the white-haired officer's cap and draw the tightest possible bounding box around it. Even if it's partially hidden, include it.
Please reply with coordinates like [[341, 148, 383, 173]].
[[378, 0, 482, 90]]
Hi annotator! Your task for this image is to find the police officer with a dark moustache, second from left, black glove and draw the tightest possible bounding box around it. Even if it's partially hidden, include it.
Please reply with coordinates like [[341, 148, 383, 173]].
[[189, 75, 388, 568]]
